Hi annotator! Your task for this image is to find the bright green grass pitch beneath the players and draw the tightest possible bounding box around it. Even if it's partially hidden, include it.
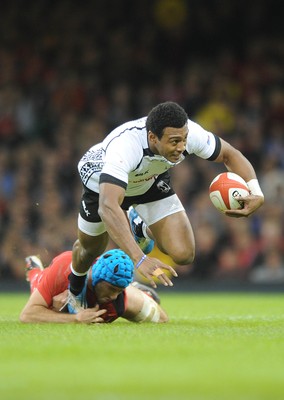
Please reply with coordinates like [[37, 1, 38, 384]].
[[0, 289, 284, 400]]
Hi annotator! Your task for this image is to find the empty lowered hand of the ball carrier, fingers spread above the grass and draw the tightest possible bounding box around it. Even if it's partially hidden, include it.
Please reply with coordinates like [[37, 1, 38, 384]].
[[137, 257, 178, 288]]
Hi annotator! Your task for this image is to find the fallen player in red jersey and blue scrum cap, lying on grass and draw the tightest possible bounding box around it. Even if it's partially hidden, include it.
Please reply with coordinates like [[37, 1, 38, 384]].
[[20, 249, 168, 324]]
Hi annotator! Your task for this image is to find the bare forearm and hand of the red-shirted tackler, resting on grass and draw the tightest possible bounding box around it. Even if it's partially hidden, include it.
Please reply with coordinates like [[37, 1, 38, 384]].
[[20, 289, 106, 324]]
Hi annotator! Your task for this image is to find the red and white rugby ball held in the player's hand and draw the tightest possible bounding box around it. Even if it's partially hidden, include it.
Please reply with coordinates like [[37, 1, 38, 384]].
[[209, 172, 250, 211]]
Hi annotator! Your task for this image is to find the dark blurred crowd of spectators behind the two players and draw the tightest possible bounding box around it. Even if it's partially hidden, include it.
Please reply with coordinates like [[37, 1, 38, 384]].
[[0, 0, 284, 283]]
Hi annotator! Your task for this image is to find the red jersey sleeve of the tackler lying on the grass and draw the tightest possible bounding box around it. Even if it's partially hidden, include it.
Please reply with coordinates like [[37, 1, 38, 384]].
[[37, 251, 72, 307]]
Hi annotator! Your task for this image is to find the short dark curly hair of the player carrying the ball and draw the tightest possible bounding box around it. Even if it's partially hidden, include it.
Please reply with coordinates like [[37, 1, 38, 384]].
[[146, 101, 188, 139]]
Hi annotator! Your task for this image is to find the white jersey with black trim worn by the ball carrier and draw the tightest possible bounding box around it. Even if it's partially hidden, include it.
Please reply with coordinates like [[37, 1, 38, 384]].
[[78, 117, 220, 197]]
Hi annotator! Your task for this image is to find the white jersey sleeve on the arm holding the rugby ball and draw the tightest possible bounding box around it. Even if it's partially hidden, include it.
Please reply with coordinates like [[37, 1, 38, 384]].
[[186, 120, 220, 159]]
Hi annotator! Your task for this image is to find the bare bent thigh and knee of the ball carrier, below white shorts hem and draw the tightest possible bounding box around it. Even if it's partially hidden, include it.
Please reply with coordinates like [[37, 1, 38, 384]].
[[150, 211, 195, 264]]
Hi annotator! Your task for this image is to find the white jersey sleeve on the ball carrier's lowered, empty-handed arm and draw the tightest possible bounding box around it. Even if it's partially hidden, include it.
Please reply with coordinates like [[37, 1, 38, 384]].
[[101, 135, 143, 185]]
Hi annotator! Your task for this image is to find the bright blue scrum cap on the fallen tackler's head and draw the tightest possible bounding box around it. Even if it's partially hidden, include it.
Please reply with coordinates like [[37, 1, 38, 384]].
[[92, 249, 134, 288]]
